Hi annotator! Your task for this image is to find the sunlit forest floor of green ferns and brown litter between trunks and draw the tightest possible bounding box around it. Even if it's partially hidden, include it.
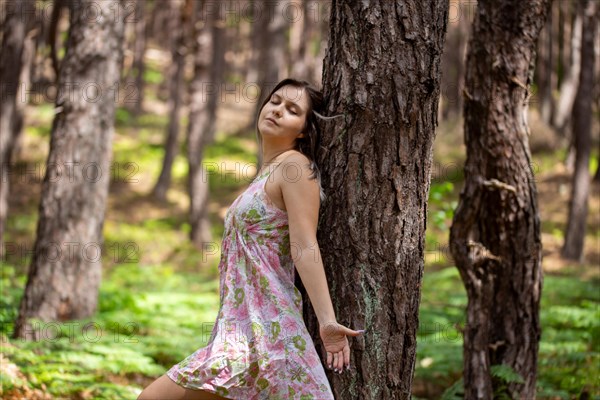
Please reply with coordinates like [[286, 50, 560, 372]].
[[0, 73, 600, 399]]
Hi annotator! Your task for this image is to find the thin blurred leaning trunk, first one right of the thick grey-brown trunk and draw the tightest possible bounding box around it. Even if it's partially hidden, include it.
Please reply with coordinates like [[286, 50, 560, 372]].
[[152, 0, 193, 201]]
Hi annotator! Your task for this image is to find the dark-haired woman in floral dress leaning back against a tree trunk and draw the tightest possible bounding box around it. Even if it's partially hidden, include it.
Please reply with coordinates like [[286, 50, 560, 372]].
[[138, 79, 364, 400]]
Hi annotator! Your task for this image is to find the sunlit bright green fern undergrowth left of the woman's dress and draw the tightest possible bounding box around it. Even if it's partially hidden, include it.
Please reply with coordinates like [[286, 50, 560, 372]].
[[0, 265, 218, 399]]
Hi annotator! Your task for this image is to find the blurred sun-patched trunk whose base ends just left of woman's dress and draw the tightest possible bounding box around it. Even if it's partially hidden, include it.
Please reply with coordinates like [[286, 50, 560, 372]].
[[187, 7, 225, 249]]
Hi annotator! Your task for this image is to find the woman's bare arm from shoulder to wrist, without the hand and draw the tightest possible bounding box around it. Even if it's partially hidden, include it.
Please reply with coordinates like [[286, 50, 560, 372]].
[[278, 153, 336, 326]]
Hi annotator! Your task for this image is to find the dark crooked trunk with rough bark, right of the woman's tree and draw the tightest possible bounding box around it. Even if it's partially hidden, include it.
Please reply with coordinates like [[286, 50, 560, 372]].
[[450, 0, 549, 399]]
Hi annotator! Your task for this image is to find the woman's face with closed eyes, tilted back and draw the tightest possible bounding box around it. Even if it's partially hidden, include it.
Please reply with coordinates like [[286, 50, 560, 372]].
[[258, 85, 309, 142]]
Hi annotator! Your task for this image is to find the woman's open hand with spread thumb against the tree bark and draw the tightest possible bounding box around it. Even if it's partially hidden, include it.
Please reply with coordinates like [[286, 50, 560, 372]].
[[319, 322, 365, 373]]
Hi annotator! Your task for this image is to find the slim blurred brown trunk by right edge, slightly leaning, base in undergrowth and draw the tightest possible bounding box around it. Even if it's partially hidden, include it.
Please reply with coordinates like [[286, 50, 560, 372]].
[[561, 0, 598, 261]]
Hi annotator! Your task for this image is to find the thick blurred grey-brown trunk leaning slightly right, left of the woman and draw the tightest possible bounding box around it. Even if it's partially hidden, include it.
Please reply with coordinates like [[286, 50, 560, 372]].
[[14, 0, 123, 339]]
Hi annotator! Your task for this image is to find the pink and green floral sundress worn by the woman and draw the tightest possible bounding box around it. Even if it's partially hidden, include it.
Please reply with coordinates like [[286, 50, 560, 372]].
[[167, 167, 334, 400]]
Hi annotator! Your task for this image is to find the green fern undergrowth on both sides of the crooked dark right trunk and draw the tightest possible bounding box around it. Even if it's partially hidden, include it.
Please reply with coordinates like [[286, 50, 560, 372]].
[[415, 268, 600, 399]]
